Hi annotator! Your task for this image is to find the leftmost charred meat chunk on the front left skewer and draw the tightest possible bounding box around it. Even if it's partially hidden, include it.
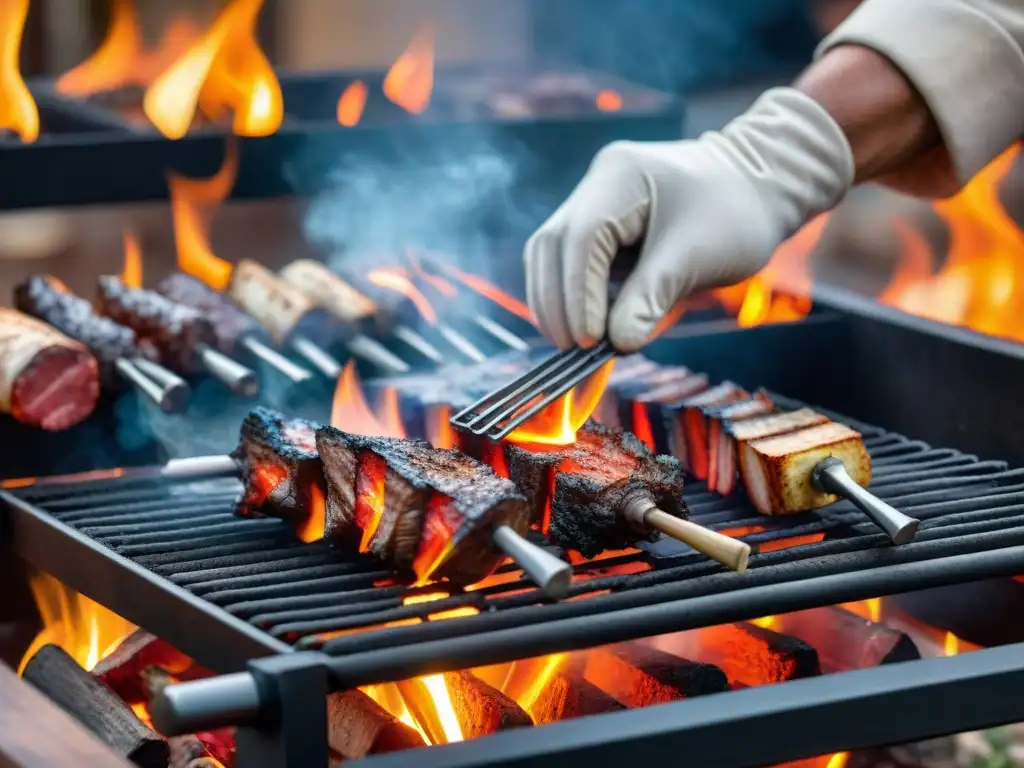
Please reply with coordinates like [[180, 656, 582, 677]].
[[231, 407, 324, 538]]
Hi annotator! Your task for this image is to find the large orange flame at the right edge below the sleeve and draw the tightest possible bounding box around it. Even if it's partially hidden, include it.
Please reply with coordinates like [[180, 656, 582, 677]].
[[879, 144, 1024, 341]]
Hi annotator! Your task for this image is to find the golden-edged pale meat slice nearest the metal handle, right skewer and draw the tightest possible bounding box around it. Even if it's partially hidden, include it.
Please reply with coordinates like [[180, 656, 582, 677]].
[[739, 422, 871, 515]]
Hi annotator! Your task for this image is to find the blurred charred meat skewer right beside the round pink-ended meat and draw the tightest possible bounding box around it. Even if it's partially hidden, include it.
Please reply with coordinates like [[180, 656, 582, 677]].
[[14, 274, 189, 413]]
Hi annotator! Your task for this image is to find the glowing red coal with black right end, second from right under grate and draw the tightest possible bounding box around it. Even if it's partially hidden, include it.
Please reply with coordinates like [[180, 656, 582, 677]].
[[650, 623, 821, 686]]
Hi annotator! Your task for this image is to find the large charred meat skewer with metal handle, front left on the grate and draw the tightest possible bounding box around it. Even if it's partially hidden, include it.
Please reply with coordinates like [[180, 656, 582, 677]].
[[231, 408, 570, 596]]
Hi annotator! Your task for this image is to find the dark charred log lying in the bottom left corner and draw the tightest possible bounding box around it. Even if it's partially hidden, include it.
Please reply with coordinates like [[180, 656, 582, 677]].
[[23, 645, 170, 768]]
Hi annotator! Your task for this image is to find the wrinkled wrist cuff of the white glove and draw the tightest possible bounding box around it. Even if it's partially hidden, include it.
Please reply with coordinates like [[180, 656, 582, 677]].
[[700, 88, 854, 240]]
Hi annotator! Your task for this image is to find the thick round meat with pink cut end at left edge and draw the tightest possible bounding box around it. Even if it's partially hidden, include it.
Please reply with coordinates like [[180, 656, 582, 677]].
[[0, 307, 99, 431]]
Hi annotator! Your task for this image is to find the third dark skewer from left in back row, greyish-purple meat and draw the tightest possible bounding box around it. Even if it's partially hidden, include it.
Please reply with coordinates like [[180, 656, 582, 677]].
[[157, 272, 312, 384]]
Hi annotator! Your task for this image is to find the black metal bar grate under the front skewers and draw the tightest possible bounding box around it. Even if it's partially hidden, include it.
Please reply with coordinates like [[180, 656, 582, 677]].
[[7, 395, 1024, 671]]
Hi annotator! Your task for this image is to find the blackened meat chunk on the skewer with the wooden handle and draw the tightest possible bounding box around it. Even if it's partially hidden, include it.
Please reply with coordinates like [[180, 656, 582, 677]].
[[504, 422, 688, 557]]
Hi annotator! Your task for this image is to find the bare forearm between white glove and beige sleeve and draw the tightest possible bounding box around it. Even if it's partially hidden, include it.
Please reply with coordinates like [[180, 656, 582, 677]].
[[795, 45, 941, 182]]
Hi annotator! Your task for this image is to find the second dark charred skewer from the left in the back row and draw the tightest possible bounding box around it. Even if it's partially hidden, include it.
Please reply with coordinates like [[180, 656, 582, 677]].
[[98, 275, 259, 396]]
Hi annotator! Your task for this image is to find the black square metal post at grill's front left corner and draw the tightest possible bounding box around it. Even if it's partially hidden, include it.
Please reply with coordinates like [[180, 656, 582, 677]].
[[236, 652, 330, 768]]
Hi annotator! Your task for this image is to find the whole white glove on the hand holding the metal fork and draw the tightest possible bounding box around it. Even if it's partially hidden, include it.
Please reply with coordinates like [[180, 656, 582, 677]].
[[523, 88, 854, 351]]
